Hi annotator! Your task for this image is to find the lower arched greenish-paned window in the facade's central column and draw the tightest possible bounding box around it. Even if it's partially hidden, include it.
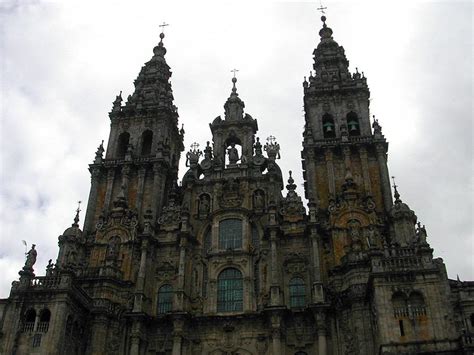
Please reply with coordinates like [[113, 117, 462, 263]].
[[217, 268, 243, 312]]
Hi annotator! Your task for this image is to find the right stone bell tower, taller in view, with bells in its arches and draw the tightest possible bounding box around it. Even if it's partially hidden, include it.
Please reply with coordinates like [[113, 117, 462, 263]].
[[302, 16, 392, 277]]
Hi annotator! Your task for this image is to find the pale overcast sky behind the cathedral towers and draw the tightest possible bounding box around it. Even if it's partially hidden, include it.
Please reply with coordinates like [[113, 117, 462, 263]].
[[0, 0, 474, 297]]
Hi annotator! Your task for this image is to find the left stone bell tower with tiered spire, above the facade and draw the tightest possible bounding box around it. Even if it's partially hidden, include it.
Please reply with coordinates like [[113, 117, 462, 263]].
[[84, 33, 184, 234]]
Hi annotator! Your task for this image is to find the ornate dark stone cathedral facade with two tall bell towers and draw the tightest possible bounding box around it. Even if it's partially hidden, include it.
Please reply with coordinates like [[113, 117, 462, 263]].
[[0, 16, 474, 355]]
